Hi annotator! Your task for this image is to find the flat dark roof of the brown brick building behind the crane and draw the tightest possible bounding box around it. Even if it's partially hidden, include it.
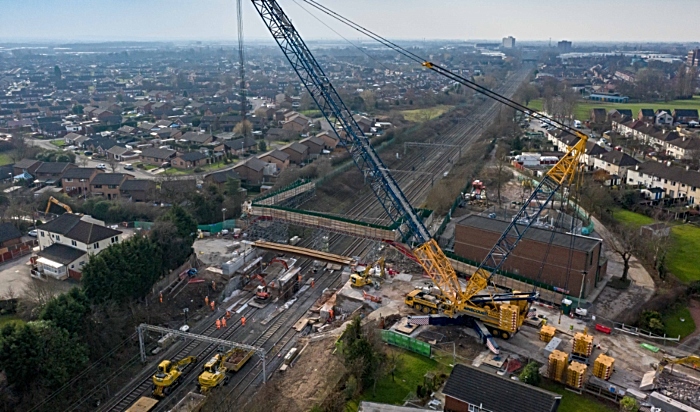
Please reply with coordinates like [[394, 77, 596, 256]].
[[457, 215, 601, 252]]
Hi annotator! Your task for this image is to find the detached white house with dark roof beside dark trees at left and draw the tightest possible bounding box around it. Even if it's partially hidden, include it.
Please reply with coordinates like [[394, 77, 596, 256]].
[[32, 213, 122, 280]]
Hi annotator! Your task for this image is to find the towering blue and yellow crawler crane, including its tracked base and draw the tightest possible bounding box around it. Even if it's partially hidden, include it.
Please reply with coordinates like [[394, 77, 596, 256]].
[[251, 0, 588, 342]]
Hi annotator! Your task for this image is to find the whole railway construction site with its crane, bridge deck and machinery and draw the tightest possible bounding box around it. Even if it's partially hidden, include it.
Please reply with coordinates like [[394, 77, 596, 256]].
[[74, 0, 700, 412]]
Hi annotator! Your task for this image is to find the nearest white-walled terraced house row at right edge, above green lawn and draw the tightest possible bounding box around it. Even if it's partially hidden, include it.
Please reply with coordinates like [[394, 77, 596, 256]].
[[627, 162, 700, 205]]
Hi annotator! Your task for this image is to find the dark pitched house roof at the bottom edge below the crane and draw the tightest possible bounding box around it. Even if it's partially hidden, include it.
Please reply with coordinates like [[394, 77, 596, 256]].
[[442, 364, 561, 412]]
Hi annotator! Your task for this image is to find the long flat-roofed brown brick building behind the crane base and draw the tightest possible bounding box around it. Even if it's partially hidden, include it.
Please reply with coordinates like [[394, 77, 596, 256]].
[[454, 215, 607, 298]]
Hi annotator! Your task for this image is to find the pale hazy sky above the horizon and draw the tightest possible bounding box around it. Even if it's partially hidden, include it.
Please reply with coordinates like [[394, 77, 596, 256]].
[[0, 0, 700, 41]]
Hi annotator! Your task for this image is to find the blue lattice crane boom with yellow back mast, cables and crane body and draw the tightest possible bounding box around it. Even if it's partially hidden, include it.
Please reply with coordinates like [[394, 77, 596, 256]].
[[251, 0, 587, 337]]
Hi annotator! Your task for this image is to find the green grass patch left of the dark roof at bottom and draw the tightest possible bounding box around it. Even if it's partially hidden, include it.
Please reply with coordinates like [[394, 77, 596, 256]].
[[346, 351, 449, 412]]
